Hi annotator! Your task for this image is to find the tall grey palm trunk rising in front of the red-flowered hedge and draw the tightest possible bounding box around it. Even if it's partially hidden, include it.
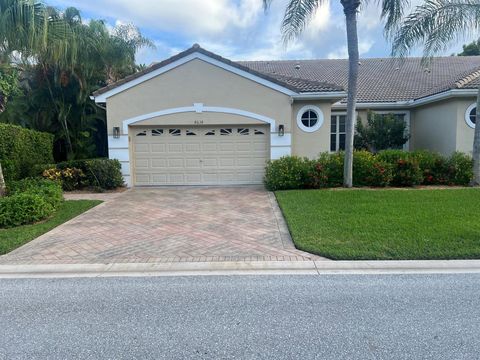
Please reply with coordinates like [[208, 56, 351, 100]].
[[341, 0, 360, 188]]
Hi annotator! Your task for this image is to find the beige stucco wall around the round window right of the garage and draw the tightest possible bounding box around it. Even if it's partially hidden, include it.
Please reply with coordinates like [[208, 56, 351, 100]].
[[291, 101, 331, 158]]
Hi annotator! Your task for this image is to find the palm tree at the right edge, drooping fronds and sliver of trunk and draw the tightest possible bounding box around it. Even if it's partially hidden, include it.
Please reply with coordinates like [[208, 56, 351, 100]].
[[392, 0, 480, 186]]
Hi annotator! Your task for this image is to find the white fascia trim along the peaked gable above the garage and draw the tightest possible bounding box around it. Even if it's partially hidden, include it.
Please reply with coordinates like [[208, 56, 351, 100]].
[[95, 52, 297, 103]]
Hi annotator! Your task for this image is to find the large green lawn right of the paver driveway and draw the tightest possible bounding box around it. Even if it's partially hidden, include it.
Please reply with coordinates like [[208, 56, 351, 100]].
[[276, 189, 480, 259]]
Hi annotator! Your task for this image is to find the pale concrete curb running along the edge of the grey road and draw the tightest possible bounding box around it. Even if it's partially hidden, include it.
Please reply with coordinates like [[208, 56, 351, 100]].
[[0, 260, 480, 279]]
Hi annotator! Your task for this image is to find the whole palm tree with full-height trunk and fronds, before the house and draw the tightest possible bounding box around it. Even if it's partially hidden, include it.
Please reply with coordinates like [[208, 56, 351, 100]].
[[263, 0, 409, 187]]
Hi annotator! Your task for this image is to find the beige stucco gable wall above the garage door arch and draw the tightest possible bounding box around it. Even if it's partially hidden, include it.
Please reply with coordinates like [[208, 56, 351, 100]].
[[107, 59, 291, 133]]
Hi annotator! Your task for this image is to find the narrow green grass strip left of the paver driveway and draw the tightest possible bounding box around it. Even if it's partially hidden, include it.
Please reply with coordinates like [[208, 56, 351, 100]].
[[0, 200, 101, 255]]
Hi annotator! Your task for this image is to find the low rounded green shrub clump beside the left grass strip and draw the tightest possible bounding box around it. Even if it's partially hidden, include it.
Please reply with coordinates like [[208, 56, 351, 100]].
[[0, 179, 63, 228]]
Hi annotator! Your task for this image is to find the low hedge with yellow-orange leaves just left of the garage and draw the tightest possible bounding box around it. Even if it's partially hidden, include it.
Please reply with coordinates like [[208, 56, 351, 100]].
[[36, 159, 125, 191]]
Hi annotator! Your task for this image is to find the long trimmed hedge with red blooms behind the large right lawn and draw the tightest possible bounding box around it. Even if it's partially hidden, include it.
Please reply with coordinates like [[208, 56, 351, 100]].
[[265, 150, 473, 191]]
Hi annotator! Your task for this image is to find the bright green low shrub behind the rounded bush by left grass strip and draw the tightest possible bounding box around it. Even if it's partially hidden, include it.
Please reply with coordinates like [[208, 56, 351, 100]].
[[7, 178, 63, 210]]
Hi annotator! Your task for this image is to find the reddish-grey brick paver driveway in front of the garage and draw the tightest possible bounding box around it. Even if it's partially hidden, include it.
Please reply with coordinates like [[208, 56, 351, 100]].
[[0, 187, 317, 263]]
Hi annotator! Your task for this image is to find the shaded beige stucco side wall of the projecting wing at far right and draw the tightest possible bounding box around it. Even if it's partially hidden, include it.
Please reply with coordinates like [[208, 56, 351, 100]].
[[410, 100, 458, 155]]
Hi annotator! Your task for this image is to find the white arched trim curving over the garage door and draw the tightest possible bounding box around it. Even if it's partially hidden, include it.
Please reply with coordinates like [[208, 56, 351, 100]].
[[122, 105, 276, 134]]
